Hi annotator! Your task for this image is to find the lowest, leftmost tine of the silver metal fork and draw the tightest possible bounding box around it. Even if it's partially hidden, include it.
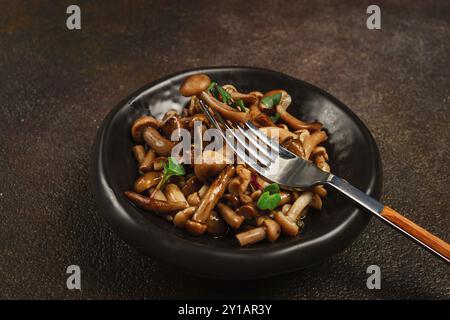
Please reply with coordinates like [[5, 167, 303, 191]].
[[200, 101, 270, 173]]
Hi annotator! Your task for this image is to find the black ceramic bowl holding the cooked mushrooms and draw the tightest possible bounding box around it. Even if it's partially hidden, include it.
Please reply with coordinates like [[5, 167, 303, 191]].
[[90, 67, 382, 279]]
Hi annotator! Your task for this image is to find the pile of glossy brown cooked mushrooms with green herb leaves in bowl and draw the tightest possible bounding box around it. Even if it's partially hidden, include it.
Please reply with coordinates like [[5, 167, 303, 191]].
[[125, 74, 330, 246]]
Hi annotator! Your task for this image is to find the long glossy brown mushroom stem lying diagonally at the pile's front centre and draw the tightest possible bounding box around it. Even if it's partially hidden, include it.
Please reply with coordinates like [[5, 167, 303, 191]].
[[192, 166, 235, 223]]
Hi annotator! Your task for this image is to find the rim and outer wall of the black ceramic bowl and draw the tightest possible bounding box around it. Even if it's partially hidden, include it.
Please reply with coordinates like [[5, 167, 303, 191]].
[[89, 66, 382, 279]]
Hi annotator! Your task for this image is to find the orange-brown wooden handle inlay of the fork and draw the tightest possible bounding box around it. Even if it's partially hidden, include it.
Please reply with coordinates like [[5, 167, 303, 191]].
[[381, 206, 450, 259]]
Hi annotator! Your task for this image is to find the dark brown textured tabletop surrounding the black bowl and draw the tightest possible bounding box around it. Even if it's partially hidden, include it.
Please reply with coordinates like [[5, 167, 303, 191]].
[[0, 1, 450, 299]]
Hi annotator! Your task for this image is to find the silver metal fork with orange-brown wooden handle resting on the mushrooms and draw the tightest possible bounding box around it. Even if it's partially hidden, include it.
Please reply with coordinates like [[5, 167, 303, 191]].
[[199, 100, 450, 263]]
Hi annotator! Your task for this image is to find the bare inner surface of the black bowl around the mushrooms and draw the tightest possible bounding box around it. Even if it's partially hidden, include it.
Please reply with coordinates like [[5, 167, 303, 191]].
[[96, 68, 381, 276]]
